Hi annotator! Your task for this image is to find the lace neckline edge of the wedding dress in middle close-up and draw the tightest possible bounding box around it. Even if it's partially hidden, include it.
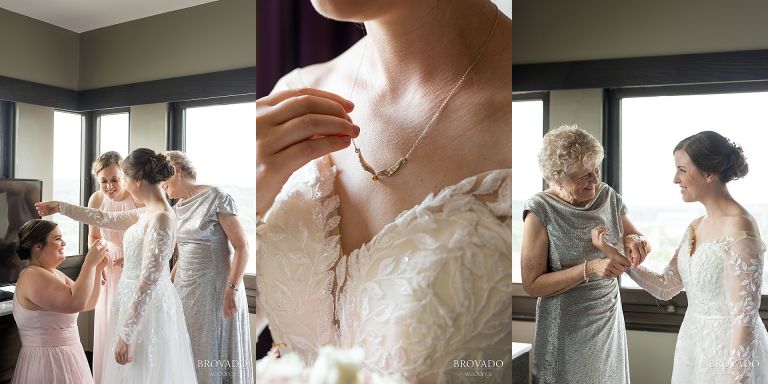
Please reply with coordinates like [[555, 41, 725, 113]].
[[315, 155, 512, 258]]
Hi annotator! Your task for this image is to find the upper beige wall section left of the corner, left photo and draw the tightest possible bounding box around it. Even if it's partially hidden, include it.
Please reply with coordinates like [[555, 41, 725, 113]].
[[0, 8, 80, 89]]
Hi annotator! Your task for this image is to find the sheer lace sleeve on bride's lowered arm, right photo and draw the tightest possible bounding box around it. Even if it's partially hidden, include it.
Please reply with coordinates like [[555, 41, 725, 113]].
[[725, 237, 765, 383]]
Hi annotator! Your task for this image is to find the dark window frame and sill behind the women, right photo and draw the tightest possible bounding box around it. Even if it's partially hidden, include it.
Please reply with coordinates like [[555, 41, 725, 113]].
[[512, 81, 768, 333]]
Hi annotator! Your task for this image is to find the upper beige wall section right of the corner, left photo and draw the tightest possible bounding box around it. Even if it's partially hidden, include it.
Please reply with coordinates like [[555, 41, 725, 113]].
[[79, 0, 256, 89]]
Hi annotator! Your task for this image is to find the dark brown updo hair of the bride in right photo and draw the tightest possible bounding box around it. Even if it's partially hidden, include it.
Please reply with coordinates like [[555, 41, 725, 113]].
[[672, 131, 749, 183]]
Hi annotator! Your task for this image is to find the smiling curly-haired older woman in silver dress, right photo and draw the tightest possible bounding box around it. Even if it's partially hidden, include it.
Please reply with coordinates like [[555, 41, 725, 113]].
[[521, 126, 649, 384]]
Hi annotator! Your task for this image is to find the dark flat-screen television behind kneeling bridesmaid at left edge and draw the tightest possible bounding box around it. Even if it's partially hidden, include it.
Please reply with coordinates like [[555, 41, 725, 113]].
[[0, 179, 43, 286]]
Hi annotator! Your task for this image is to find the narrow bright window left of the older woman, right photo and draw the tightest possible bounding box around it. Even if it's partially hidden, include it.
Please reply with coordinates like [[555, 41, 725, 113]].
[[512, 97, 545, 283]]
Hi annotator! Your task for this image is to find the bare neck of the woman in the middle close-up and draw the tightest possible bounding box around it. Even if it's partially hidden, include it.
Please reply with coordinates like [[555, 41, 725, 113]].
[[360, 0, 504, 96]]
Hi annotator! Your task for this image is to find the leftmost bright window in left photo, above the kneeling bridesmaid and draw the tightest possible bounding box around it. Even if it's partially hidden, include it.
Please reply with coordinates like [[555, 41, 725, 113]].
[[51, 111, 83, 256]]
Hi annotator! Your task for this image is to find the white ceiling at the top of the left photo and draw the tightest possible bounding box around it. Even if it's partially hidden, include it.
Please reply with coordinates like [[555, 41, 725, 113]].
[[0, 0, 215, 33]]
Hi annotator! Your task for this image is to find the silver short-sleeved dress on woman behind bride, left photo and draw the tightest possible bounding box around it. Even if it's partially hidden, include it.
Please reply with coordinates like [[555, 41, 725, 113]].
[[174, 187, 253, 383]]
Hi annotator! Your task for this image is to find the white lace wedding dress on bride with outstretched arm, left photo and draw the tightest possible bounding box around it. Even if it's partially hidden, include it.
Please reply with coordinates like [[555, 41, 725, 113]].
[[59, 203, 197, 384]]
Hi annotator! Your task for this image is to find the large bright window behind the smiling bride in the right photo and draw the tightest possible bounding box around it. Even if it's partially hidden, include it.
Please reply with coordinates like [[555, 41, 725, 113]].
[[620, 92, 768, 294]]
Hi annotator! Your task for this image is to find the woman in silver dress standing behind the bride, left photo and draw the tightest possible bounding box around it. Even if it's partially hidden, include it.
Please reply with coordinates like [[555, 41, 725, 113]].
[[163, 151, 253, 383]]
